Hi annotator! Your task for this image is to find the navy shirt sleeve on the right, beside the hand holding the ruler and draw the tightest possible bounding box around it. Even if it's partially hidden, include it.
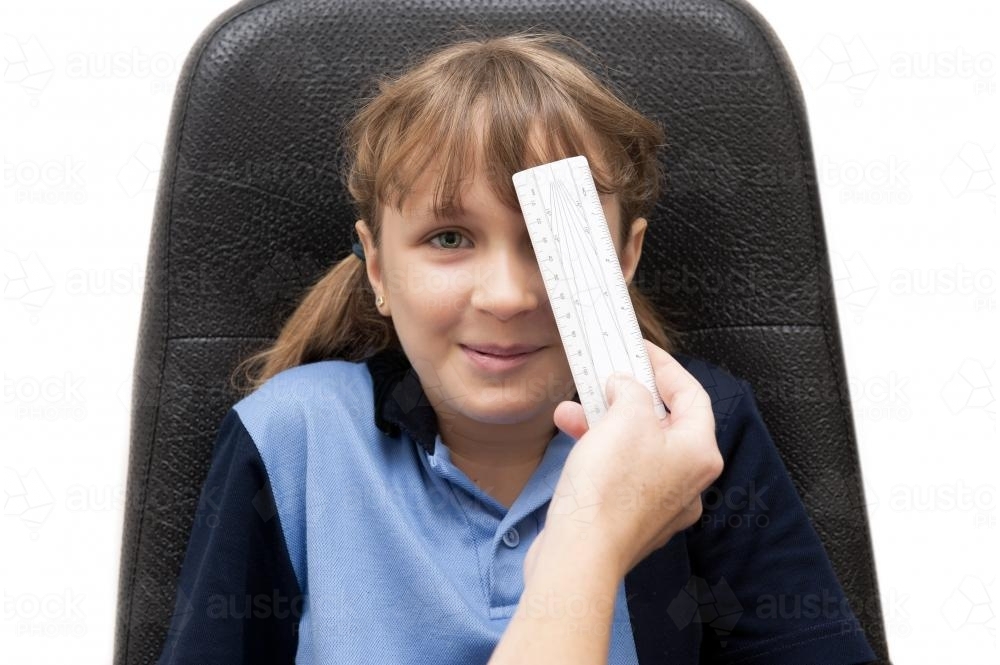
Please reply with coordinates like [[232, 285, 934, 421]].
[[686, 379, 876, 665]]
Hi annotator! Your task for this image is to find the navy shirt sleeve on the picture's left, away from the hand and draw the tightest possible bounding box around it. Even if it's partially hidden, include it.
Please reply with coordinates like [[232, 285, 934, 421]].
[[157, 409, 305, 665]]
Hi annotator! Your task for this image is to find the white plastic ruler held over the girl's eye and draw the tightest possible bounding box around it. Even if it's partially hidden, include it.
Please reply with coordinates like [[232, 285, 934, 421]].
[[513, 156, 667, 427]]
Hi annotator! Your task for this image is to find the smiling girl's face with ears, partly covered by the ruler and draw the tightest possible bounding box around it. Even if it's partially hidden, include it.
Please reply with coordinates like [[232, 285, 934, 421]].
[[356, 155, 646, 433]]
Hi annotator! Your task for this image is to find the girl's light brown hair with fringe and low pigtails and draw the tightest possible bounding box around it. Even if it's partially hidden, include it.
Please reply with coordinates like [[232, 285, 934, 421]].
[[233, 33, 676, 393]]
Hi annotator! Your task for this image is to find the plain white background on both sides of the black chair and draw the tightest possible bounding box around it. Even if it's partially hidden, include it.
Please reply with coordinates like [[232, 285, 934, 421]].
[[0, 0, 1000, 665]]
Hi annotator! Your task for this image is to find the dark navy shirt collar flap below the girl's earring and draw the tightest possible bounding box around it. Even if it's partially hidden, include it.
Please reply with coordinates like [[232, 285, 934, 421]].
[[365, 347, 580, 455]]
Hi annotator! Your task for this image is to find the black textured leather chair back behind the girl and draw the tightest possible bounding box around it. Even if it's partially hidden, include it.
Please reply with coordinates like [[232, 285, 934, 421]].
[[115, 0, 889, 664]]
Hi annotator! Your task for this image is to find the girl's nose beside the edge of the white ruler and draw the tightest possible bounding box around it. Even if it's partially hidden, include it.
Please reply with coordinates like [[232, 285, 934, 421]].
[[471, 243, 548, 321]]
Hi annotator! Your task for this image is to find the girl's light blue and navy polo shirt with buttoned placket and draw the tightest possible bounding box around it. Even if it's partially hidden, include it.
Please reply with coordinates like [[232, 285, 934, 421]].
[[158, 349, 875, 665]]
